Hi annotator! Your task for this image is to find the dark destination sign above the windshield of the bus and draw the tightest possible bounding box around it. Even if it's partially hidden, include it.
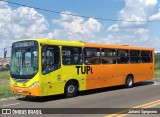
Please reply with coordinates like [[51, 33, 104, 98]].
[[12, 41, 38, 48]]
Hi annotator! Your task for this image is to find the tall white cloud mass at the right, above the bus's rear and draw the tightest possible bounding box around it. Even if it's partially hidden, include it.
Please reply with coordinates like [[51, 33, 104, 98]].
[[104, 0, 160, 49]]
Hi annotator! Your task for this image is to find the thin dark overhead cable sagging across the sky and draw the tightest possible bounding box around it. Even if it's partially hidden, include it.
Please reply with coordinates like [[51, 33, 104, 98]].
[[0, 0, 160, 23]]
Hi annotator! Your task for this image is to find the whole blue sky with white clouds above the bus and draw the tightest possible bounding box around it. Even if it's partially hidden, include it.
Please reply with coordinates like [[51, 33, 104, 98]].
[[0, 0, 160, 57]]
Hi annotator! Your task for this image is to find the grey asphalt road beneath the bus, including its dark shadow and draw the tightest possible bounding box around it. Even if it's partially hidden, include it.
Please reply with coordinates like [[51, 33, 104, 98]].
[[0, 80, 160, 117]]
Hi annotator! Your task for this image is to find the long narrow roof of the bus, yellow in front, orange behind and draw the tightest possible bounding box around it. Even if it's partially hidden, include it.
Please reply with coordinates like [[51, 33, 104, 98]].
[[16, 39, 154, 50]]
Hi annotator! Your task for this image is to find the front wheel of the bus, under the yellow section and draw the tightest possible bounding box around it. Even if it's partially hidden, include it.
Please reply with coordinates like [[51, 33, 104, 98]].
[[64, 81, 78, 98]]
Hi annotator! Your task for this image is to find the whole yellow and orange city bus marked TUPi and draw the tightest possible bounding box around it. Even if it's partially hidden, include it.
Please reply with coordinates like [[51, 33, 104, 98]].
[[10, 39, 154, 97]]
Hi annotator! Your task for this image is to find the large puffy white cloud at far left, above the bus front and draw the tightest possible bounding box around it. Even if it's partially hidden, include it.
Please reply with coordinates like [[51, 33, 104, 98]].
[[0, 2, 53, 56]]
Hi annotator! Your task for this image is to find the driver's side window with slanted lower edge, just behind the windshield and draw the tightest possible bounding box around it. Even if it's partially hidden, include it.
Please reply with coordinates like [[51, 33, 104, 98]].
[[42, 45, 60, 74]]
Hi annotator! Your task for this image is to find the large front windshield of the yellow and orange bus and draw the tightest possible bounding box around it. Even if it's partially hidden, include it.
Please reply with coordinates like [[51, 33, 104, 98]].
[[10, 41, 38, 79]]
